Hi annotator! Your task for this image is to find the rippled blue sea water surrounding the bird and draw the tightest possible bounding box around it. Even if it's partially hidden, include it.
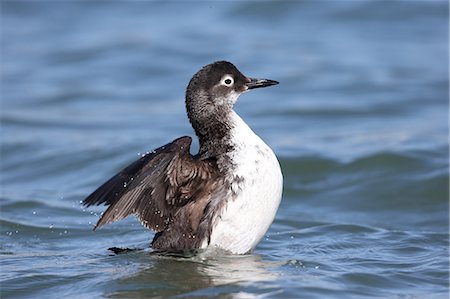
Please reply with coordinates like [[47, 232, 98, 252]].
[[0, 1, 449, 298]]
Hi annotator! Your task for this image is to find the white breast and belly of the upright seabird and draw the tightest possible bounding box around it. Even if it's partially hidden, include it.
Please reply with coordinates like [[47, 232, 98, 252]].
[[209, 113, 283, 254]]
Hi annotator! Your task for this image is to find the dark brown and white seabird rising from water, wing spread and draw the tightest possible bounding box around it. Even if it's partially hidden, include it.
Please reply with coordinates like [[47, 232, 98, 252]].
[[82, 61, 283, 254]]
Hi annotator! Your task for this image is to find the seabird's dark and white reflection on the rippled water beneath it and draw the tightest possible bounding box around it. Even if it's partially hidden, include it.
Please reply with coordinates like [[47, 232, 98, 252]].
[[106, 252, 280, 297]]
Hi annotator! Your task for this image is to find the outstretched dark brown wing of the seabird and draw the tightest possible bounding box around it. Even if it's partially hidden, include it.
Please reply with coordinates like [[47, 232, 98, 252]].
[[83, 136, 220, 232]]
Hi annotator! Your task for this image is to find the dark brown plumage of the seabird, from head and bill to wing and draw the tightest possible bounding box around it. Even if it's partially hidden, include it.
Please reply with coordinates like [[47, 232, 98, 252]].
[[83, 61, 277, 250]]
